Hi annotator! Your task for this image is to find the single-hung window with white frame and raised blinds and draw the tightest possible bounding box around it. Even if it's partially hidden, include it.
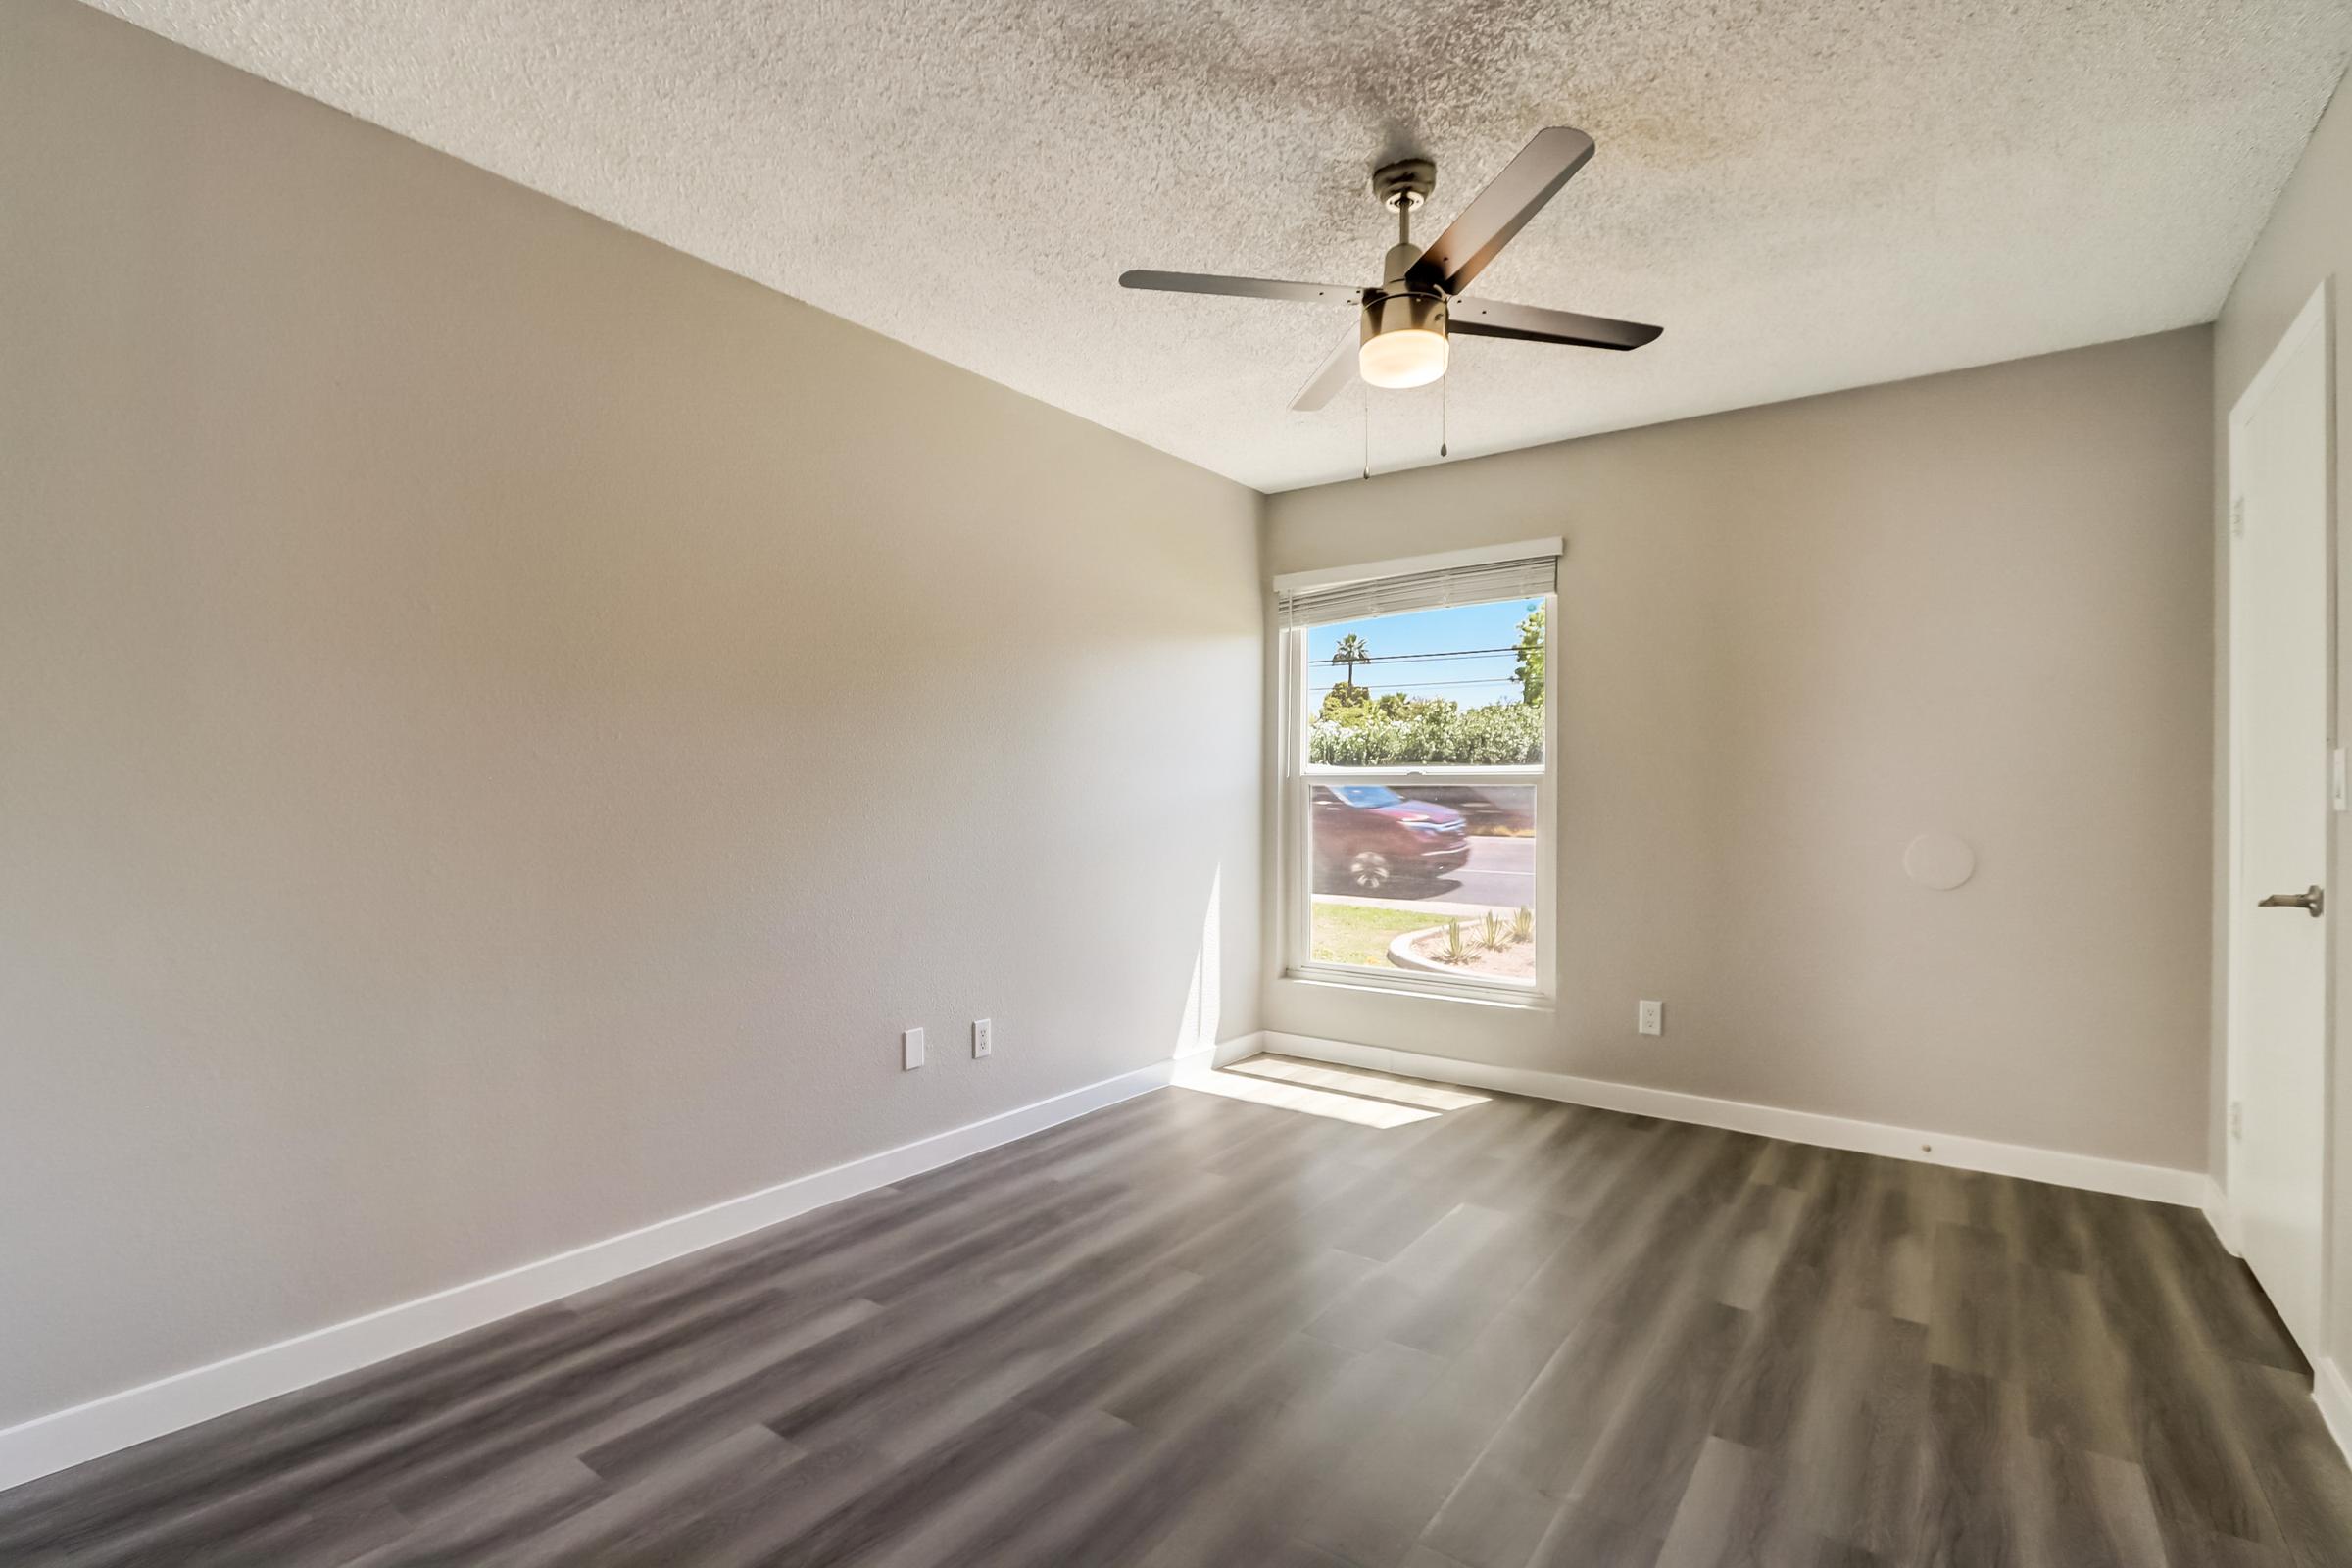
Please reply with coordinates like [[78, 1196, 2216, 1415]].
[[1275, 541, 1559, 1002]]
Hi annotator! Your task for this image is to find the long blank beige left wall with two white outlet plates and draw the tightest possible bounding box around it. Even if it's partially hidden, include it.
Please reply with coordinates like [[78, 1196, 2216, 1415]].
[[0, 0, 1263, 1427]]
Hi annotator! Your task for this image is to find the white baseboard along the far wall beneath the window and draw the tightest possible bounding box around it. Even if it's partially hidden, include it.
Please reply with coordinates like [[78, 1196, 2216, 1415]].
[[1265, 1030, 2206, 1208]]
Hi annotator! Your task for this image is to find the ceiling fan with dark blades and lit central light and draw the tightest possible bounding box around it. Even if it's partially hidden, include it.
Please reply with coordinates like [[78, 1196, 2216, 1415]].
[[1119, 124, 1665, 412]]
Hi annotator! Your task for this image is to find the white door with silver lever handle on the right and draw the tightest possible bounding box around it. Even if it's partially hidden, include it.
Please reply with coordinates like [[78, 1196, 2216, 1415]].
[[2230, 287, 2352, 1349]]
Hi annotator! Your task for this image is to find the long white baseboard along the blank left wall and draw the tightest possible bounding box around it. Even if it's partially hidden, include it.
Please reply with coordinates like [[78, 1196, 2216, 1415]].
[[0, 1034, 1260, 1491]]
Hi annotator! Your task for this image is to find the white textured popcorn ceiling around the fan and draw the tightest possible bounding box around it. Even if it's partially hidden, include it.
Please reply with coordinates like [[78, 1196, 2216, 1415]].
[[82, 0, 2352, 489]]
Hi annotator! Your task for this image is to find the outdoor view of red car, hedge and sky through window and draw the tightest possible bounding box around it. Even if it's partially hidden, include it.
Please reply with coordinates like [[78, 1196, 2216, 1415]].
[[1298, 600, 1550, 985]]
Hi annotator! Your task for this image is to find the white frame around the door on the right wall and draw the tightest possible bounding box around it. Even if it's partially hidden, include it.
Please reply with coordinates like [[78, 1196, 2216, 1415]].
[[2221, 277, 2352, 1368]]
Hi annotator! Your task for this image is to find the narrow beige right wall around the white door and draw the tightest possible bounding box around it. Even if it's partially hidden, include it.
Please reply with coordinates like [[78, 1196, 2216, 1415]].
[[2209, 73, 2352, 1366]]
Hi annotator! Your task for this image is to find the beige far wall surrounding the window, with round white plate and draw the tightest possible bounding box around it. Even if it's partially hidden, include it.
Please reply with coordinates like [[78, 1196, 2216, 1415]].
[[1265, 329, 2213, 1168]]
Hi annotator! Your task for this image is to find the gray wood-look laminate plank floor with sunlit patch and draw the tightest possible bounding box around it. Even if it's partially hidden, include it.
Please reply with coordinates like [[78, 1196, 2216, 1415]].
[[0, 1057, 2352, 1568]]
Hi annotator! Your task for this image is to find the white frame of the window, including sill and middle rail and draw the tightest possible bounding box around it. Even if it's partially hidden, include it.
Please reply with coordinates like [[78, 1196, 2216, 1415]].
[[1275, 541, 1559, 1008]]
